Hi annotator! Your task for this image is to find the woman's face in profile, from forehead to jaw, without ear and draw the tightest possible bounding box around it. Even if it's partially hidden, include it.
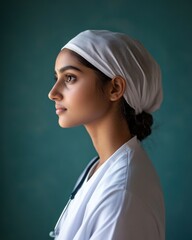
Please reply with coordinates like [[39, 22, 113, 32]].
[[49, 49, 111, 128]]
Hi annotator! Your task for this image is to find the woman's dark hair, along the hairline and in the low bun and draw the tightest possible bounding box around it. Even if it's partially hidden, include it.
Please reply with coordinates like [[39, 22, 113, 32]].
[[70, 50, 153, 141]]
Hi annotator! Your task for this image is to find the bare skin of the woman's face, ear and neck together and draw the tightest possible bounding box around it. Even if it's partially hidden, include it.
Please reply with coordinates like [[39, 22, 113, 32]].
[[49, 49, 131, 171]]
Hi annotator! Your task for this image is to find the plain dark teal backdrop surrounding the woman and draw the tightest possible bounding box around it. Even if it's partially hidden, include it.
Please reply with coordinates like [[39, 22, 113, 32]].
[[0, 0, 192, 240]]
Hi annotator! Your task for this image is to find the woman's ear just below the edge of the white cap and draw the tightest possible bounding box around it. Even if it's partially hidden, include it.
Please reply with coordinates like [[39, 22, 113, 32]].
[[110, 76, 126, 101]]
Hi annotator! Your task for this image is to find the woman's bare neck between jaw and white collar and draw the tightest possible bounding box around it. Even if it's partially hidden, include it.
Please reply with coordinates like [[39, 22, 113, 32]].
[[85, 112, 131, 165]]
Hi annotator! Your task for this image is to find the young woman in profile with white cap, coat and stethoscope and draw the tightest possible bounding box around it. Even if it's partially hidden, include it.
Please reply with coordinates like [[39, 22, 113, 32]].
[[49, 30, 165, 240]]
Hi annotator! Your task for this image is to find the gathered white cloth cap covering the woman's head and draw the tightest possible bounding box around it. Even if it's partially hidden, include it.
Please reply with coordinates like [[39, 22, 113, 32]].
[[62, 30, 163, 114]]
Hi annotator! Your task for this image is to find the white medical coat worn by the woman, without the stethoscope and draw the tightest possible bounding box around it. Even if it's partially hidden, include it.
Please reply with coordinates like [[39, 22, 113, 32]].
[[52, 137, 165, 240]]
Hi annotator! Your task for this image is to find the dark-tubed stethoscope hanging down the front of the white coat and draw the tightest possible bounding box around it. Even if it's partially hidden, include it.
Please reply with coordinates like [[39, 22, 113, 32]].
[[49, 157, 99, 238]]
